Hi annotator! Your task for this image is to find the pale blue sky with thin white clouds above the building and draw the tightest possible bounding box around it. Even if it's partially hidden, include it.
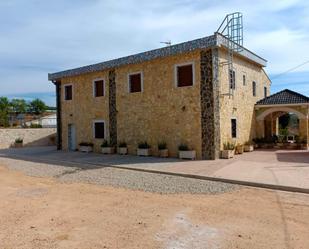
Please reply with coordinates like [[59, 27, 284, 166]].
[[0, 0, 309, 104]]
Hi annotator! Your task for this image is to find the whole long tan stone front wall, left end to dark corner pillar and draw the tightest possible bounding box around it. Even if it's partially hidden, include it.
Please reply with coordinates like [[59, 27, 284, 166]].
[[61, 51, 201, 158]]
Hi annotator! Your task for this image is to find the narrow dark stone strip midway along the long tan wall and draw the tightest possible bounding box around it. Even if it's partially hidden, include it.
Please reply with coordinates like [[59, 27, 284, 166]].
[[108, 70, 117, 146]]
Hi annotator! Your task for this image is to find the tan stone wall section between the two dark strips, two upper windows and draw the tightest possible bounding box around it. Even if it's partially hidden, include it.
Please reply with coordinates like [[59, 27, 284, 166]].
[[116, 51, 201, 158]]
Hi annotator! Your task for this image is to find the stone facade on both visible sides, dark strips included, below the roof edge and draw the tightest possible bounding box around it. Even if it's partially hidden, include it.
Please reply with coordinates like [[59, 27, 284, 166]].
[[54, 48, 270, 159]]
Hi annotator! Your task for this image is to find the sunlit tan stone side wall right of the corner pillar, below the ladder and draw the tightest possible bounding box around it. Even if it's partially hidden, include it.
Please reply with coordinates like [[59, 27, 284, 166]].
[[219, 50, 270, 149]]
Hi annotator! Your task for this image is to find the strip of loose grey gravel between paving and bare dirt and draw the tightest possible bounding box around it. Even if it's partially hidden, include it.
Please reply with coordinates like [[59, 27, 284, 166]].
[[0, 158, 240, 194]]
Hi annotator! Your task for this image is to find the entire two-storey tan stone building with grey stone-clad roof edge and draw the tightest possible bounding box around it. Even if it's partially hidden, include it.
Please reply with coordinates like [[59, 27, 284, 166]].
[[49, 33, 270, 159]]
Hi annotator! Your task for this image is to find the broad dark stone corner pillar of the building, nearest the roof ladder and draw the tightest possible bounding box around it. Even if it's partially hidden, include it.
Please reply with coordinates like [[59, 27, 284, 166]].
[[200, 49, 220, 160]]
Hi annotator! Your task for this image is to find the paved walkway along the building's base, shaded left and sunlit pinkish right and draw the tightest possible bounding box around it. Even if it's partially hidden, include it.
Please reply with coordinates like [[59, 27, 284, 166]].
[[0, 147, 309, 193]]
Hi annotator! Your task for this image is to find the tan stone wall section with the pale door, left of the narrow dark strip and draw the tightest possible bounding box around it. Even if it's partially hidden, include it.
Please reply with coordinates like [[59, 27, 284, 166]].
[[61, 71, 110, 152]]
